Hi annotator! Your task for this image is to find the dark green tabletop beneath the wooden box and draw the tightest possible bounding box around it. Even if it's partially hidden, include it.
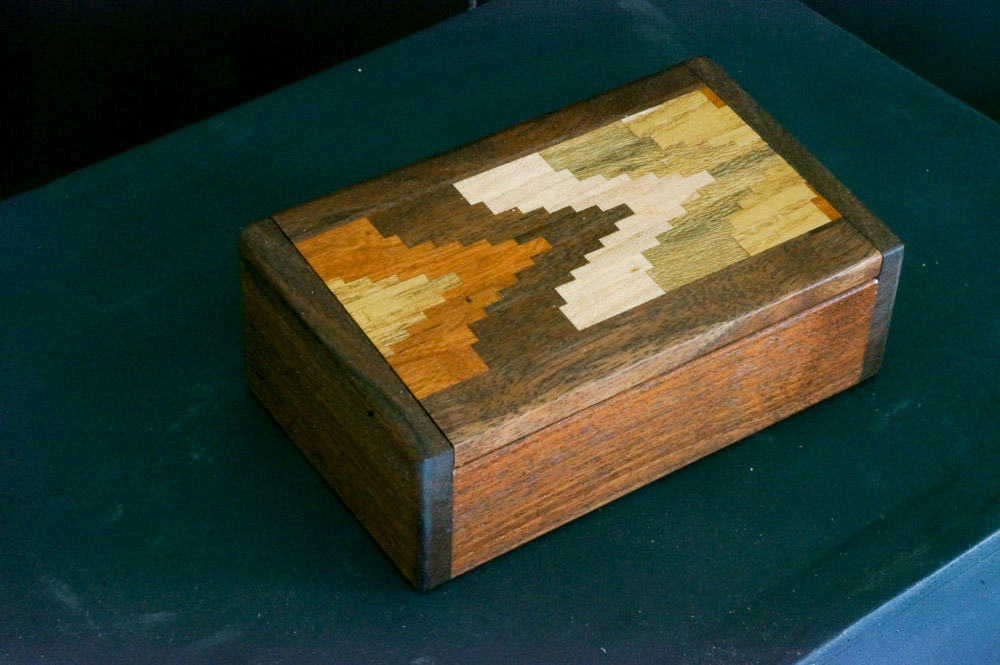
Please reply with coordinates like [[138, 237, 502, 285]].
[[0, 0, 1000, 665]]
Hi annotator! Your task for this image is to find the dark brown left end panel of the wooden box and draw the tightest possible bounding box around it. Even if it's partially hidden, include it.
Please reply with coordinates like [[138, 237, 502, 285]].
[[240, 220, 453, 588]]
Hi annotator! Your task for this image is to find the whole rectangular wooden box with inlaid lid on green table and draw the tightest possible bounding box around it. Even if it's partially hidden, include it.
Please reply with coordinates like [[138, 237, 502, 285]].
[[241, 59, 902, 588]]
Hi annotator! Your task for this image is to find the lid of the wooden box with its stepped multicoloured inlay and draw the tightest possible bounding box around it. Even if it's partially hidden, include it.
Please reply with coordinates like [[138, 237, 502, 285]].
[[276, 59, 880, 464]]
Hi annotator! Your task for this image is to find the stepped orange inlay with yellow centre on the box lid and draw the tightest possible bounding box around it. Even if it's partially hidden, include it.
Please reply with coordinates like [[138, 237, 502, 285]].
[[296, 217, 549, 399]]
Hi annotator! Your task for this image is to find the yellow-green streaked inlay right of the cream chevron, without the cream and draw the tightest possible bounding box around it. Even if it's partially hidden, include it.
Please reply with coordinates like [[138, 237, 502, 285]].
[[623, 88, 840, 291]]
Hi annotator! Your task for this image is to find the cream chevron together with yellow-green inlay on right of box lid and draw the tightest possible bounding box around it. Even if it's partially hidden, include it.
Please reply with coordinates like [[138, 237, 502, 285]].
[[446, 88, 839, 329]]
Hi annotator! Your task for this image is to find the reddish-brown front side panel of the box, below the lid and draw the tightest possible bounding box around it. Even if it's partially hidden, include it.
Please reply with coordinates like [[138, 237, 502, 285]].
[[452, 281, 877, 575]]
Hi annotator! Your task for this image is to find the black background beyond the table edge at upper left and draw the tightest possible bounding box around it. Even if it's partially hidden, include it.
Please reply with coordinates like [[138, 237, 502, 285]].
[[0, 0, 469, 198]]
